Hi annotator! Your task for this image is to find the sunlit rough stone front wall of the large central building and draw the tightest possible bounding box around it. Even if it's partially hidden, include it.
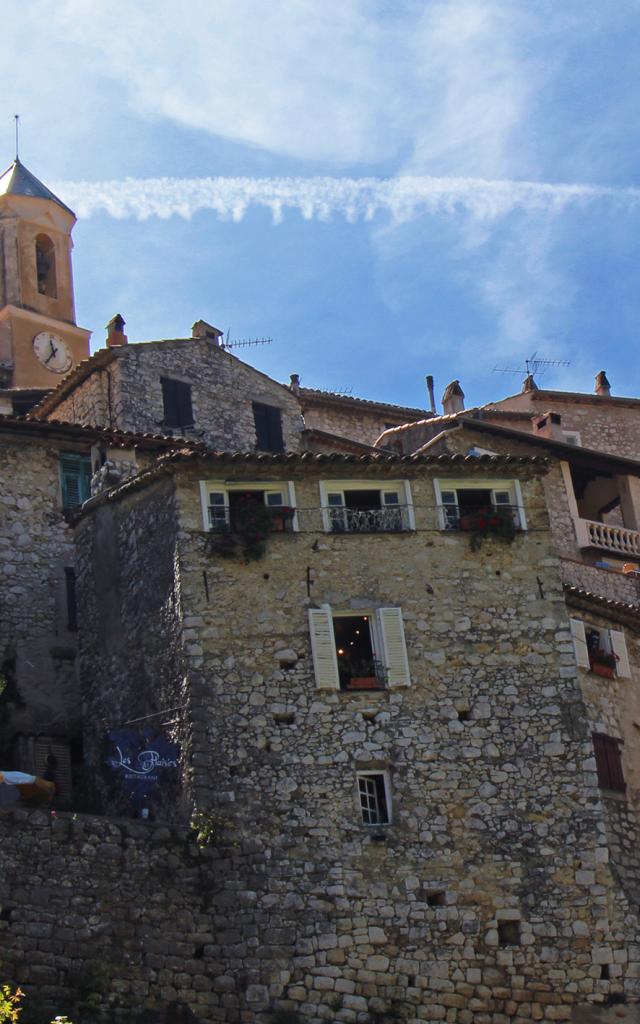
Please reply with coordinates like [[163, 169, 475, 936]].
[[66, 462, 640, 1024]]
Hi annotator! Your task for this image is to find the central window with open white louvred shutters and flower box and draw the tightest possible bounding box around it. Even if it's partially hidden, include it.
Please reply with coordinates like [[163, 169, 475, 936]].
[[309, 605, 411, 690]]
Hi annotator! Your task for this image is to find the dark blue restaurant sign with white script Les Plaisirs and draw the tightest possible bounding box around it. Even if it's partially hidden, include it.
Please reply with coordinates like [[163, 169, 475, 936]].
[[105, 729, 180, 803]]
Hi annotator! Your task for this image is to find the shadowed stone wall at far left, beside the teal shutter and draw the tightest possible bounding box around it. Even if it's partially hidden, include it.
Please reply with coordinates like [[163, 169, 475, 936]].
[[0, 432, 80, 757]]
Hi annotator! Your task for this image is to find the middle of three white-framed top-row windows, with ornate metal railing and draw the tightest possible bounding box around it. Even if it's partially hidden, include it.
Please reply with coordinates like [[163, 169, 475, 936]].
[[321, 480, 416, 534]]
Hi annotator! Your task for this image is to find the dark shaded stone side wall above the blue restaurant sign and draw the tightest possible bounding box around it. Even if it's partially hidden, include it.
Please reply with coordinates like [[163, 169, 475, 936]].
[[76, 477, 189, 818]]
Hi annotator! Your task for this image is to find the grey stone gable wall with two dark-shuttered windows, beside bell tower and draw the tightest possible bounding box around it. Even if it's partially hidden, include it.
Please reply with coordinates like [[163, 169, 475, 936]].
[[49, 339, 303, 452]]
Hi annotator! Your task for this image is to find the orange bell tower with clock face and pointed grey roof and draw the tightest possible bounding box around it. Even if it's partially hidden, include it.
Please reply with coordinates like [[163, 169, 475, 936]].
[[0, 158, 91, 390]]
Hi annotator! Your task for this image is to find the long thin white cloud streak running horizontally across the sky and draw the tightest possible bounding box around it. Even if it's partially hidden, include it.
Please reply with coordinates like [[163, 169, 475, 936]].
[[54, 176, 640, 223]]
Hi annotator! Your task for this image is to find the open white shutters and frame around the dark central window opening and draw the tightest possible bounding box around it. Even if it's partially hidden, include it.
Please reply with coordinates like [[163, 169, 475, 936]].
[[308, 604, 411, 690]]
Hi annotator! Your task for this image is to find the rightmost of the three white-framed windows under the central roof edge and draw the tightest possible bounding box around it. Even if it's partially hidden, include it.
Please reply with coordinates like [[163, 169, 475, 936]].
[[435, 479, 526, 529]]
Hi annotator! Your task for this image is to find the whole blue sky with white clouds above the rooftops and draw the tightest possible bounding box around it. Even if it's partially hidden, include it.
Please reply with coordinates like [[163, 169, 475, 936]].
[[0, 0, 640, 406]]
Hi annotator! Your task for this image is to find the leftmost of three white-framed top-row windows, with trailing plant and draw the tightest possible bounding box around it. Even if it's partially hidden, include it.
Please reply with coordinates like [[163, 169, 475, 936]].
[[200, 480, 298, 532]]
